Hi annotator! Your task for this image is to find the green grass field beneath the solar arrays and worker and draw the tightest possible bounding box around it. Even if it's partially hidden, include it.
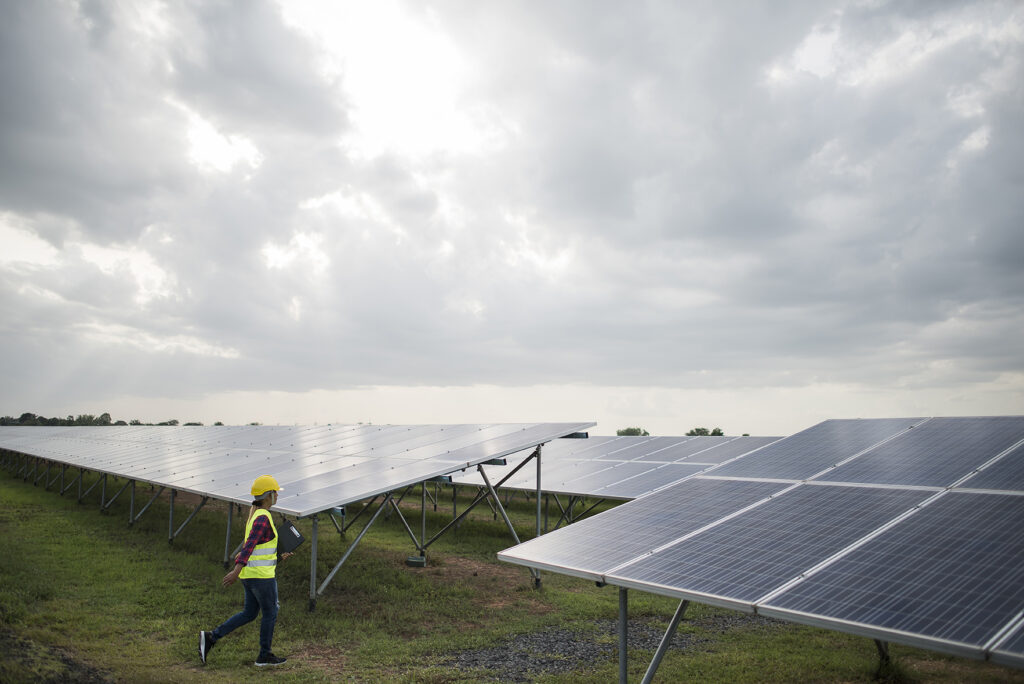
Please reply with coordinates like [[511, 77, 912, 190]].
[[0, 464, 1024, 682]]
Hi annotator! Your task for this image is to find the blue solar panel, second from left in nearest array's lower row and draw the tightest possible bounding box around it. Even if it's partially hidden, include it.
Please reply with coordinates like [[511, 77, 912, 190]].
[[608, 484, 931, 603]]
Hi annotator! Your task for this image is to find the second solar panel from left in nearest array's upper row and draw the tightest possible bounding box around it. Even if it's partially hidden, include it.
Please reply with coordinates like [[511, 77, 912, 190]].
[[820, 416, 1024, 486]]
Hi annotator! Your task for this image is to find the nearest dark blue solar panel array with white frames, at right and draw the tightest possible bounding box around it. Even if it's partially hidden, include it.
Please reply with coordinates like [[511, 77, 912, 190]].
[[499, 417, 1024, 667]]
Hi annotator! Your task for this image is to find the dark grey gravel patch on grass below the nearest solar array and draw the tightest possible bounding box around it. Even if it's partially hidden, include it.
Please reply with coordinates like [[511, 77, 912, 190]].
[[446, 613, 778, 682]]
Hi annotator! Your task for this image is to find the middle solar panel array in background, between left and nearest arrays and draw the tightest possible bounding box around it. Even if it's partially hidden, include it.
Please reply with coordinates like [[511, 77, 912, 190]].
[[452, 436, 780, 500]]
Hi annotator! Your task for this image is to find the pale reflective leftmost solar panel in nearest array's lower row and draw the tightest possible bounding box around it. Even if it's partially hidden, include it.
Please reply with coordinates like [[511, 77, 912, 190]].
[[498, 479, 785, 580]]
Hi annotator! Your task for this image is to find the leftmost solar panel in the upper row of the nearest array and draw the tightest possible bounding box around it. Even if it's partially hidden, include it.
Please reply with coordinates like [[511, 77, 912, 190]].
[[714, 418, 922, 480]]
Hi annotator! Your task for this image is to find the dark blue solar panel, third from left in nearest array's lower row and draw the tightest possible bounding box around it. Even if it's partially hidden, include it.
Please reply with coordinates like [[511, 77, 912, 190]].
[[768, 490, 1024, 647]]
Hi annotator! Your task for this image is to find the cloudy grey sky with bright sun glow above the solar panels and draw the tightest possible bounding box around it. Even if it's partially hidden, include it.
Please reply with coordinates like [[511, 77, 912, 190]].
[[0, 0, 1024, 434]]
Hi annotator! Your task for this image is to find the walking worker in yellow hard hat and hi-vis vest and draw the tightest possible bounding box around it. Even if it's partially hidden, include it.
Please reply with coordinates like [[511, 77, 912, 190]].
[[199, 475, 292, 668]]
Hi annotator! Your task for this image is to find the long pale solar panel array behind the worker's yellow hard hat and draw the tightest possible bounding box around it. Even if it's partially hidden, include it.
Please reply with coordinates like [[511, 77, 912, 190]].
[[0, 423, 593, 516]]
